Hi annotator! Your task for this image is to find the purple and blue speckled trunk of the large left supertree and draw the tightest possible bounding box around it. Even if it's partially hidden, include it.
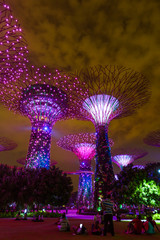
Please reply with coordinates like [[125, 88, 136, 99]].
[[26, 122, 52, 169]]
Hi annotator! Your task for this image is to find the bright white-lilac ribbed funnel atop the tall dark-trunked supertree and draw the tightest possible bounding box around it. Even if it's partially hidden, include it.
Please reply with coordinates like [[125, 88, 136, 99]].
[[83, 94, 119, 125]]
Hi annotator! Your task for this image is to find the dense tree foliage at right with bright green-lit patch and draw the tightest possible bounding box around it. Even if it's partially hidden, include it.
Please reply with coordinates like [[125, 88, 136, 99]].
[[113, 163, 160, 206]]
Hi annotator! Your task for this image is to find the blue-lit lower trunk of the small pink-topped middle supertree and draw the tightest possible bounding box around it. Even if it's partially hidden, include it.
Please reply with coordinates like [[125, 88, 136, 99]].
[[77, 172, 93, 208]]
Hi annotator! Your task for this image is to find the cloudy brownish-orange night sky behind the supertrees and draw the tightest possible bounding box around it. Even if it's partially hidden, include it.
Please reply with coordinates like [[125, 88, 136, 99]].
[[0, 0, 160, 191]]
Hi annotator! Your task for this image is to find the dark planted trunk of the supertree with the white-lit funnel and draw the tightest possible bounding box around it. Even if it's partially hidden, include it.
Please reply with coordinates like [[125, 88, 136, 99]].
[[94, 126, 114, 210]]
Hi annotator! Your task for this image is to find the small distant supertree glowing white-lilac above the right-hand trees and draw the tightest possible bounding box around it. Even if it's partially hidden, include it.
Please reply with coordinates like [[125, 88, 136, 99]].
[[112, 149, 147, 170]]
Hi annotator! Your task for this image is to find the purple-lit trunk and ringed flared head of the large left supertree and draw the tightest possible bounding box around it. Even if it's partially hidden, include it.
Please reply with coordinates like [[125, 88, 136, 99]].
[[20, 84, 67, 168]]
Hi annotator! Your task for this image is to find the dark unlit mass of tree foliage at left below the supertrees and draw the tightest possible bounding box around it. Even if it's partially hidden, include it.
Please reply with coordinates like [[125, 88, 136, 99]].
[[0, 164, 73, 209]]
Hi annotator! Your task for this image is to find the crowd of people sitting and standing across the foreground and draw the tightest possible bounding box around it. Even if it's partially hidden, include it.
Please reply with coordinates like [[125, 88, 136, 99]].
[[15, 194, 160, 236]]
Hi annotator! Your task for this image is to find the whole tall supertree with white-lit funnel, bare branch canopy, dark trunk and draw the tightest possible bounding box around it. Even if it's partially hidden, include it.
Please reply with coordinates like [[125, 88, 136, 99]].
[[74, 65, 150, 208]]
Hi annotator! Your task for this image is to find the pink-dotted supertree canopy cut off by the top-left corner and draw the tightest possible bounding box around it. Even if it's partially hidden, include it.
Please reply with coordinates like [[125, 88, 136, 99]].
[[0, 1, 28, 84]]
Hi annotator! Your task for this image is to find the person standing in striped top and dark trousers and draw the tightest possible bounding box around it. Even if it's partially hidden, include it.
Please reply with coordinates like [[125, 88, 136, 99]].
[[102, 194, 114, 236]]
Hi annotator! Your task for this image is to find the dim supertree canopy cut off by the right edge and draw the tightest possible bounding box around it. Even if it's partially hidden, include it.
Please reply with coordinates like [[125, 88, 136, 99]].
[[144, 130, 160, 147]]
